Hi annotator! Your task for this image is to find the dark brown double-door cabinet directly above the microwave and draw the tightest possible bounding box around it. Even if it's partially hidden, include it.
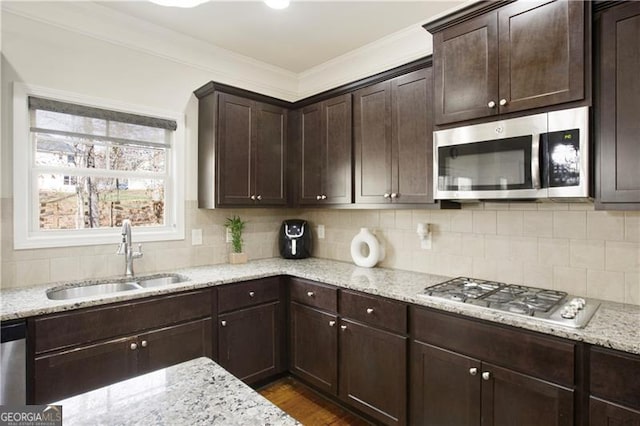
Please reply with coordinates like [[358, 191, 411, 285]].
[[426, 0, 586, 125]]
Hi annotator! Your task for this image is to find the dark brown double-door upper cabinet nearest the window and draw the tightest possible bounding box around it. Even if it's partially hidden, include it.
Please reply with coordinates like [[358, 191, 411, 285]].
[[198, 91, 287, 208]]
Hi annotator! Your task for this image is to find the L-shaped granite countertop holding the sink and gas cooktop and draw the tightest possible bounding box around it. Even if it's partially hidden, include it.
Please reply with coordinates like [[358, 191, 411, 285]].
[[0, 258, 640, 354]]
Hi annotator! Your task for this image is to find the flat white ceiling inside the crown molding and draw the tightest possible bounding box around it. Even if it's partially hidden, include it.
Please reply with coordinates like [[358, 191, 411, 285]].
[[99, 0, 468, 74]]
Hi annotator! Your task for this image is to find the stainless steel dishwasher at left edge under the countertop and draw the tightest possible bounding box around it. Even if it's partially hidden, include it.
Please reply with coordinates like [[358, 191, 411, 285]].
[[0, 321, 27, 405]]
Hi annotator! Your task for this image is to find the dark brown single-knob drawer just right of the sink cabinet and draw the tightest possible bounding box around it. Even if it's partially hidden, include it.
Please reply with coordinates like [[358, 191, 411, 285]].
[[218, 277, 280, 312]]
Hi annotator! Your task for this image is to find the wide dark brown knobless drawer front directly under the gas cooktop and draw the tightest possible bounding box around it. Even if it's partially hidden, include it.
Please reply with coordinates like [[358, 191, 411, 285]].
[[410, 307, 576, 386]]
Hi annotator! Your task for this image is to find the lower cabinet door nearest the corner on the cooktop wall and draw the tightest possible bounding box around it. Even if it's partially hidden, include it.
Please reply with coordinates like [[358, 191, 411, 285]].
[[289, 303, 338, 394]]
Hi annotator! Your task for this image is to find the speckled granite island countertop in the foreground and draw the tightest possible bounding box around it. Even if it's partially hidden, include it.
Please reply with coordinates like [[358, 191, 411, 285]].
[[53, 358, 300, 426]]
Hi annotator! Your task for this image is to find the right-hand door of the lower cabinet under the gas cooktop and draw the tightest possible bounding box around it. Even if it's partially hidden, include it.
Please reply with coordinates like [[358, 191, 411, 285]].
[[482, 363, 574, 426]]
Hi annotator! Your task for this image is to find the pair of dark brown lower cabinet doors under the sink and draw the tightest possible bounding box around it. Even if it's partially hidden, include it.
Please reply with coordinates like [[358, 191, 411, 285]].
[[33, 318, 211, 404]]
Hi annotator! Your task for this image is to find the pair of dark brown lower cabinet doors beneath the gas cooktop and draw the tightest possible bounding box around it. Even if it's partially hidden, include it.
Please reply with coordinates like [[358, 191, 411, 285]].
[[410, 341, 574, 426]]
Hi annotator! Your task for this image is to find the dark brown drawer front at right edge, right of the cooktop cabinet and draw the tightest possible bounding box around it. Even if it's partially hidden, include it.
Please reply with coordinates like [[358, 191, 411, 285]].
[[589, 347, 640, 410]]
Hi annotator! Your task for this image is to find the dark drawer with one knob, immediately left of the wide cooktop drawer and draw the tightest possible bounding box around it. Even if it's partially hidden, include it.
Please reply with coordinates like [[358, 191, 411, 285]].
[[340, 290, 407, 334]]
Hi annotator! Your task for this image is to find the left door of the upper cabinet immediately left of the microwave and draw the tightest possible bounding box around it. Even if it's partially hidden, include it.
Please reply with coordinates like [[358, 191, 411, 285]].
[[353, 81, 391, 203]]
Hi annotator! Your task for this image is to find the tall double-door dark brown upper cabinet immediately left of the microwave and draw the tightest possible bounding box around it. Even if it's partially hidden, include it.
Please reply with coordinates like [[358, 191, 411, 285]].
[[354, 68, 433, 204]]
